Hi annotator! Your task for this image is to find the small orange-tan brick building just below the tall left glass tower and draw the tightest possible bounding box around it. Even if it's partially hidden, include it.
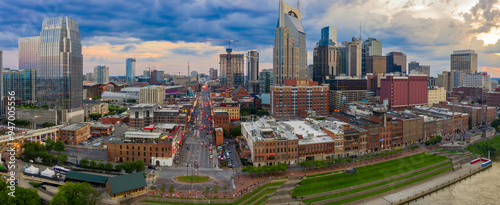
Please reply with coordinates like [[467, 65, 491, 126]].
[[59, 123, 90, 145]]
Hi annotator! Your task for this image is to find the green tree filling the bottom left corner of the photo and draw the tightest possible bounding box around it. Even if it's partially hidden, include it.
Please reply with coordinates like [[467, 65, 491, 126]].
[[0, 180, 42, 205]]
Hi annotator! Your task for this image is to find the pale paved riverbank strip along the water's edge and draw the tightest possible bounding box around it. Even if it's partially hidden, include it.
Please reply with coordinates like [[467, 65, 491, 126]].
[[358, 155, 492, 205]]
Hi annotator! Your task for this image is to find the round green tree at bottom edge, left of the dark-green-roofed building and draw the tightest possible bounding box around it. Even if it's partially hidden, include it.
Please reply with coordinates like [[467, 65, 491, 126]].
[[49, 182, 102, 205]]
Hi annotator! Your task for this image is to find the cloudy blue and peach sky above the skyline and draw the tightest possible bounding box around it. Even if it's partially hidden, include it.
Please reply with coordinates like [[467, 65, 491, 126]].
[[0, 0, 500, 77]]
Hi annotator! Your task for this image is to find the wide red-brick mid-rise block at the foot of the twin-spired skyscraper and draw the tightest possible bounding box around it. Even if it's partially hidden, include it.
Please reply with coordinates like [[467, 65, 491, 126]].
[[271, 79, 330, 119]]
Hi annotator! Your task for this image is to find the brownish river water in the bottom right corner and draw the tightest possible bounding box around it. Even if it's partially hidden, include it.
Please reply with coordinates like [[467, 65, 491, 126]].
[[410, 154, 500, 205]]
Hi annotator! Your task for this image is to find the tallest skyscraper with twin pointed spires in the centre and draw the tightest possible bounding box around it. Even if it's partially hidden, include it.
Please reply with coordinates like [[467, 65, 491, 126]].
[[273, 0, 307, 85]]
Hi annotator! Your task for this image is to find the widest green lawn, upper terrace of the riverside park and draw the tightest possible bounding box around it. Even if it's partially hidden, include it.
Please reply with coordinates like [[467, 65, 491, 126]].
[[293, 153, 447, 196]]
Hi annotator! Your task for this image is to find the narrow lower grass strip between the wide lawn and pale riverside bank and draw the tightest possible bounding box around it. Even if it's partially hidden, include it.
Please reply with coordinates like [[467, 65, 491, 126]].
[[304, 162, 452, 203]]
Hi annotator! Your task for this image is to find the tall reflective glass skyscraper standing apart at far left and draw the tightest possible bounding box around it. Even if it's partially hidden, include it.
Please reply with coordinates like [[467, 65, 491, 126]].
[[36, 17, 83, 109]]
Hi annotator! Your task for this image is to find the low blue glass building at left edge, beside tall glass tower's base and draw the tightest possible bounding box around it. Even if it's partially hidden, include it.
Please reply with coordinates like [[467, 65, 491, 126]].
[[2, 68, 36, 103]]
